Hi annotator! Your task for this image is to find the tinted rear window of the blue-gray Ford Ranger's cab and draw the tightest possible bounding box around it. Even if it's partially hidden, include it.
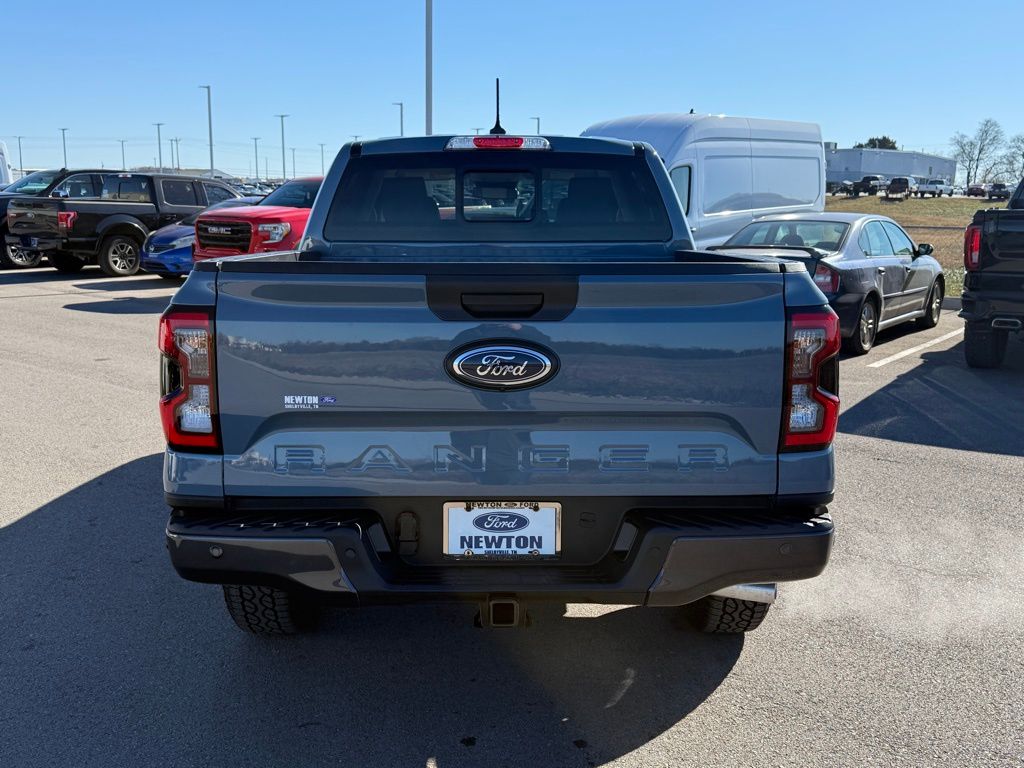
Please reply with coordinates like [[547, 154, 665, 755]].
[[324, 151, 672, 243]]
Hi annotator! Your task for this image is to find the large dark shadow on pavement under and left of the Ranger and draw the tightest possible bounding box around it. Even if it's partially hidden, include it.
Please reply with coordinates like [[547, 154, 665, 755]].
[[0, 455, 742, 768]]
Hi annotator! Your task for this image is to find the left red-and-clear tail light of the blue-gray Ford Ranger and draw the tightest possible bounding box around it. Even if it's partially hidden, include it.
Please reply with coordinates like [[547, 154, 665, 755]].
[[159, 307, 220, 452]]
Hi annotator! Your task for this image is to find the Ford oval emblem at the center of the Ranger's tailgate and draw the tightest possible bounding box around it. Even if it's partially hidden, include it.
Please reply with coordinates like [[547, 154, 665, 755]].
[[447, 343, 557, 390]]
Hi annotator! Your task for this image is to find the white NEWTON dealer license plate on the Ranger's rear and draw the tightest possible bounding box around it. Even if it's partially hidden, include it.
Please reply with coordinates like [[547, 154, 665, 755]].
[[444, 502, 562, 559]]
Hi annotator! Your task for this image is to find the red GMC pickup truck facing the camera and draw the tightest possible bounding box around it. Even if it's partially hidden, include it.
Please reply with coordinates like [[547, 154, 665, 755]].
[[193, 178, 324, 261]]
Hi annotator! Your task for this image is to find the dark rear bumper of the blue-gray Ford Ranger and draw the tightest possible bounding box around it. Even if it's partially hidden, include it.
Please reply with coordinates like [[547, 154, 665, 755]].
[[167, 507, 833, 606]]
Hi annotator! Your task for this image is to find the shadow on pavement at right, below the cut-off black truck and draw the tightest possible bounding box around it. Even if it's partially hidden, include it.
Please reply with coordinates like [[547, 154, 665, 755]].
[[839, 338, 1024, 456]]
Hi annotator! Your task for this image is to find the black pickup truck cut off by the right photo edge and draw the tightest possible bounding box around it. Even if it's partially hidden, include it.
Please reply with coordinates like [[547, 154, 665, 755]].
[[961, 181, 1024, 368]]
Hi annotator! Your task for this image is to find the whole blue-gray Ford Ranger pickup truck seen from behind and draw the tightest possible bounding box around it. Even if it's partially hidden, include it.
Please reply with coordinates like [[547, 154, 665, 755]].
[[159, 135, 840, 634]]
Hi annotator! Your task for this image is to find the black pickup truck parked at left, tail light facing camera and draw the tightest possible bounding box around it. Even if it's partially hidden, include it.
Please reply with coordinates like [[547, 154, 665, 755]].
[[6, 172, 240, 278]]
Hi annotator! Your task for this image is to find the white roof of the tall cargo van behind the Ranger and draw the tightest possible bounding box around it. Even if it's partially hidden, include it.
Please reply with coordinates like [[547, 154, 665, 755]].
[[581, 113, 821, 161]]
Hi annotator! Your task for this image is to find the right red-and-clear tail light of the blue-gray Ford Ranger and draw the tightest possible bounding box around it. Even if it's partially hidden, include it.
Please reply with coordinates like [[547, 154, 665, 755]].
[[779, 306, 840, 451]]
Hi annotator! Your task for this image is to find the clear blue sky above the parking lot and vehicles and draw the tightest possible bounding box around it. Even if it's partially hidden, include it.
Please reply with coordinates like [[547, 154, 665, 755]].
[[0, 0, 1024, 174]]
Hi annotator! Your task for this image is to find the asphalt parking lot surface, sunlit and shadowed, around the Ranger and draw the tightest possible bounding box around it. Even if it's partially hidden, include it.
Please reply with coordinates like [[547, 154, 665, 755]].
[[0, 269, 1024, 768]]
